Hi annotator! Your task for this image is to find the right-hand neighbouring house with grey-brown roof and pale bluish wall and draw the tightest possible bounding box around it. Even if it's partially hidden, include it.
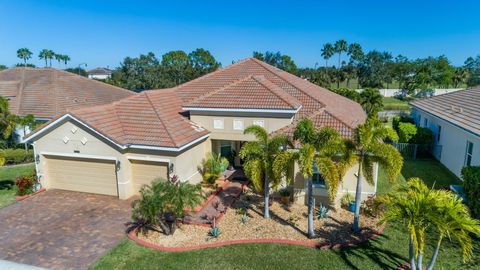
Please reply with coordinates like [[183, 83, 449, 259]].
[[411, 87, 480, 177]]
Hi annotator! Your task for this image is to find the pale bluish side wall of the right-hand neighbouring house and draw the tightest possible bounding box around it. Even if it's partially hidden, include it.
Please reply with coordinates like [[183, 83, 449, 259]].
[[413, 108, 480, 177]]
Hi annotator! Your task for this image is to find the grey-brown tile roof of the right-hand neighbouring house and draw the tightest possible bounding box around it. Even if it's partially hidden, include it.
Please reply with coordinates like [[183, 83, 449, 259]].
[[411, 87, 480, 135]]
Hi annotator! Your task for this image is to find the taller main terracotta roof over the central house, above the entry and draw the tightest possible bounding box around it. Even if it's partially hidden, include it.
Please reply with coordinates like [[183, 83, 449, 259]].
[[175, 58, 366, 134]]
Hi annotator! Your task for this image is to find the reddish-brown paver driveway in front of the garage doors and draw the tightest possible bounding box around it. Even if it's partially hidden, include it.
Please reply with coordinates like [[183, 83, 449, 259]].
[[0, 190, 130, 269]]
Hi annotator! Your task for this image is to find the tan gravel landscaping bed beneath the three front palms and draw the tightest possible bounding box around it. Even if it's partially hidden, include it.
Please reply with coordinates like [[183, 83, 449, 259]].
[[133, 187, 383, 251]]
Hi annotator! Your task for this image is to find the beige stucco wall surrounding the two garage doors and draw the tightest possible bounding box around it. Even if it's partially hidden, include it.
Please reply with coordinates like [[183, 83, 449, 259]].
[[34, 121, 211, 199]]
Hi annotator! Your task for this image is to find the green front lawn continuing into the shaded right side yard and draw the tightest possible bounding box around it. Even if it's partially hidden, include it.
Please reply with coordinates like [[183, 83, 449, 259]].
[[91, 160, 480, 270]]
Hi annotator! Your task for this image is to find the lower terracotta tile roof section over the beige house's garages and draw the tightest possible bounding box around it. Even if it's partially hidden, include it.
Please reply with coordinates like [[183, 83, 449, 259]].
[[69, 89, 209, 147]]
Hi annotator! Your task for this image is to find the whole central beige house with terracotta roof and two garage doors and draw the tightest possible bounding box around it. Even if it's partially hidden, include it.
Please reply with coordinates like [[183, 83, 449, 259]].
[[28, 58, 376, 207]]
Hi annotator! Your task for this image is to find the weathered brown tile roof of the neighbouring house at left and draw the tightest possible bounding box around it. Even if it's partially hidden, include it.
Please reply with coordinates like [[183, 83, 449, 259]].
[[0, 67, 135, 119]]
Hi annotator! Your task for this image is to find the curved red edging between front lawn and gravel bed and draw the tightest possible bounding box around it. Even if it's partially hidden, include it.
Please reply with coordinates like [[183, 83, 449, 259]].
[[127, 225, 385, 252]]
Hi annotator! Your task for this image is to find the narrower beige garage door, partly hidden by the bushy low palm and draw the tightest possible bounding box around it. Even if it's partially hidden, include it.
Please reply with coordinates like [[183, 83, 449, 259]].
[[131, 160, 168, 194]]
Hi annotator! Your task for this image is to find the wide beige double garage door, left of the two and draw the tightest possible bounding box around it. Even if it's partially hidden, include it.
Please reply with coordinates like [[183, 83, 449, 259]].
[[45, 156, 118, 196]]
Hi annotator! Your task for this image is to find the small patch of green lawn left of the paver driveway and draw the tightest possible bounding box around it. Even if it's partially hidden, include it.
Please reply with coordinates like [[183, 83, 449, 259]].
[[0, 164, 34, 208]]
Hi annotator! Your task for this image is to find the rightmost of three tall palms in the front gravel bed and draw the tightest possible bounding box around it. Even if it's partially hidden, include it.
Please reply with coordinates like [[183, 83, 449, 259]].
[[347, 117, 403, 232]]
